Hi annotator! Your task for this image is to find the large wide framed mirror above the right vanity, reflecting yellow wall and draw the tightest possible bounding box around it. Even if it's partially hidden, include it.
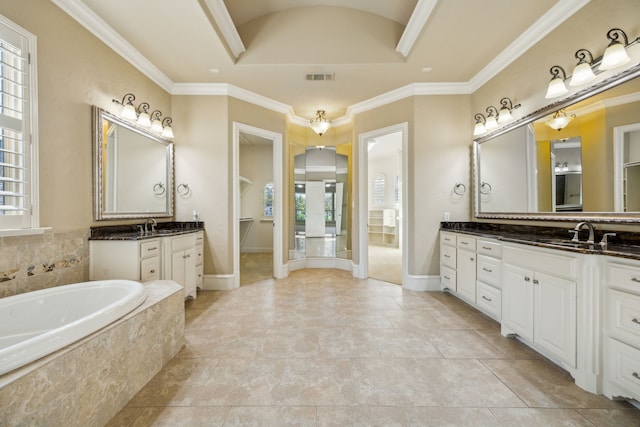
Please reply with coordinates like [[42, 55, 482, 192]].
[[473, 65, 640, 222]]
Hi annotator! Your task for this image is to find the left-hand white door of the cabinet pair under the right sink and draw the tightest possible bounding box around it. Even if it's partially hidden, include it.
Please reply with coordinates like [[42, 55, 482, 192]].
[[502, 264, 533, 340]]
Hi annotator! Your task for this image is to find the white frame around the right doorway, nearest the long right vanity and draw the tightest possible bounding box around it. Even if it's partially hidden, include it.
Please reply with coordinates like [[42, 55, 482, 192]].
[[357, 122, 409, 287]]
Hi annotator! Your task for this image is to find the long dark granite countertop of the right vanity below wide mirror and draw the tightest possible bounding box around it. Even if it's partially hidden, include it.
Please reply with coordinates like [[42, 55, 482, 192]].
[[440, 222, 640, 260]]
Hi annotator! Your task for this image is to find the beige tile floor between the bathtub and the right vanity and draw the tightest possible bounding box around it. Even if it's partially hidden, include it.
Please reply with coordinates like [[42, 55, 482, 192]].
[[108, 270, 640, 427]]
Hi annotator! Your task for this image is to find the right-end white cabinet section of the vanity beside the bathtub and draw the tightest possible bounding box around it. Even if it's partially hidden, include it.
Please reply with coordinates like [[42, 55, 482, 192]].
[[162, 232, 202, 298]]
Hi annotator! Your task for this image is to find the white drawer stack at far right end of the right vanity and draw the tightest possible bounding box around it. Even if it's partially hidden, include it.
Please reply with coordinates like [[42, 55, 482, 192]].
[[603, 258, 640, 400]]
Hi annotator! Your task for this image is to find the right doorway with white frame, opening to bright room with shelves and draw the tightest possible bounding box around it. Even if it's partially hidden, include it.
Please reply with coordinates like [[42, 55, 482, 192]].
[[360, 123, 407, 285]]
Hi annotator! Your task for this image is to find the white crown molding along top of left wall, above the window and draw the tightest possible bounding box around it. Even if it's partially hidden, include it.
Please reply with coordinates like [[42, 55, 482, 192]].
[[51, 0, 173, 92]]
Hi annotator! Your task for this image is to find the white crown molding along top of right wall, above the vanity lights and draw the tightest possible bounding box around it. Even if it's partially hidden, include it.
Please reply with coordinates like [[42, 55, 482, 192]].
[[469, 0, 591, 92]]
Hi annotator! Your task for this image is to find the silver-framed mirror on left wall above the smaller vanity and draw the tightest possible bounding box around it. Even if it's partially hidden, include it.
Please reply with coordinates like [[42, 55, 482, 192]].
[[93, 106, 173, 221]]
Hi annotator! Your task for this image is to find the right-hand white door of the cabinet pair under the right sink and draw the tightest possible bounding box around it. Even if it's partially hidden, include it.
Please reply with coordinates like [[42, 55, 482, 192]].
[[533, 273, 576, 367]]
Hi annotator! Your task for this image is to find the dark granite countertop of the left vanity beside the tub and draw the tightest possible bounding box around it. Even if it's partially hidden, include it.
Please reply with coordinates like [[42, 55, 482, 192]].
[[89, 221, 204, 240]]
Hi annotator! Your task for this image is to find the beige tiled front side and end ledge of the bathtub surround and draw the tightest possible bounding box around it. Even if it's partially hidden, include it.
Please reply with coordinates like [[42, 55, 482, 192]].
[[0, 281, 184, 427]]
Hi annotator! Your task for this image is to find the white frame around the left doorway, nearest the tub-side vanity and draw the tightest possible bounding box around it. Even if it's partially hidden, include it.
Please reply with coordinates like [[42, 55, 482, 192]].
[[232, 122, 286, 288]]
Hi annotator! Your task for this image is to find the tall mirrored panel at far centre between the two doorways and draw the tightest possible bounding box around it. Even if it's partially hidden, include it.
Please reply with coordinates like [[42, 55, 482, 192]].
[[292, 146, 350, 259]]
